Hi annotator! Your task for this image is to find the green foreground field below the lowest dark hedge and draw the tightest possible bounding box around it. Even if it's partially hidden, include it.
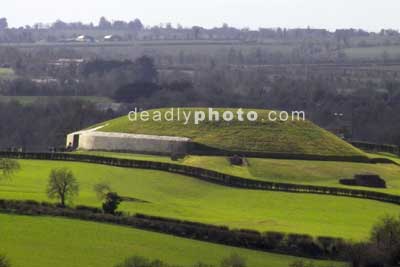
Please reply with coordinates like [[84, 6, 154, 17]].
[[0, 214, 340, 267]]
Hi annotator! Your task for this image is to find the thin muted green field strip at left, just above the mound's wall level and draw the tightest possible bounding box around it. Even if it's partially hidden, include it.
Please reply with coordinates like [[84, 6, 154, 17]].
[[0, 96, 112, 105]]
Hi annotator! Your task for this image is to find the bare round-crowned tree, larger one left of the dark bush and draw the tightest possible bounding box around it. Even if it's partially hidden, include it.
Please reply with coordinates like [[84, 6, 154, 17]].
[[47, 168, 79, 207]]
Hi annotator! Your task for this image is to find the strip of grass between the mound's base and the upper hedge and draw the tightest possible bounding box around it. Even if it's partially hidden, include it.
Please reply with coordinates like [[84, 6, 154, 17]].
[[77, 151, 400, 194]]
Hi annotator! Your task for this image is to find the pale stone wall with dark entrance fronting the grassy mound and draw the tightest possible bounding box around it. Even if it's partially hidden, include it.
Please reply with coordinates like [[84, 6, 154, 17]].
[[67, 126, 190, 154]]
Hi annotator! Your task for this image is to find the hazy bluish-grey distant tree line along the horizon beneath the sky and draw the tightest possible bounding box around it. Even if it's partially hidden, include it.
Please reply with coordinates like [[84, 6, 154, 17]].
[[0, 16, 400, 47]]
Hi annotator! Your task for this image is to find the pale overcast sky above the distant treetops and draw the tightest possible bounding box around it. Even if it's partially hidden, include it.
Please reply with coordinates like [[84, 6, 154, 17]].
[[0, 0, 400, 31]]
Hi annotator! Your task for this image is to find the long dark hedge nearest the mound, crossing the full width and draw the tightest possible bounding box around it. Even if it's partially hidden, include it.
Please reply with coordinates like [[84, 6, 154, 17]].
[[0, 151, 400, 205]]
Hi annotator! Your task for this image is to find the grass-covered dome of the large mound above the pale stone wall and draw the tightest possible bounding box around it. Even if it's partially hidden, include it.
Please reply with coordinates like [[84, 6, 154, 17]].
[[96, 108, 362, 156]]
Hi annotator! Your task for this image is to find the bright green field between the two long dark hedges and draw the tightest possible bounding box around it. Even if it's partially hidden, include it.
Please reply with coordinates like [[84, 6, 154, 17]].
[[0, 160, 400, 239]]
